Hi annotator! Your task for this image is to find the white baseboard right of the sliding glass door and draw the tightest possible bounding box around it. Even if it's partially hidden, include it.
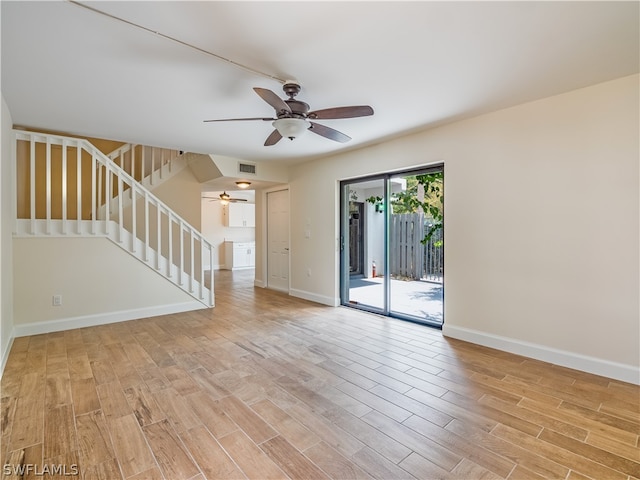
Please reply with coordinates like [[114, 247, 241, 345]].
[[442, 322, 640, 385]]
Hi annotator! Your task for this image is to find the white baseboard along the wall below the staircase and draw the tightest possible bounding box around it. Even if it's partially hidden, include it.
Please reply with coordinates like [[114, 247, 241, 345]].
[[13, 301, 204, 337]]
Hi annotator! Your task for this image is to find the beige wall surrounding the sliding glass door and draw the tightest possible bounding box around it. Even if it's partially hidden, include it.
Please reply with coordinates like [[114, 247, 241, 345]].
[[290, 75, 640, 378]]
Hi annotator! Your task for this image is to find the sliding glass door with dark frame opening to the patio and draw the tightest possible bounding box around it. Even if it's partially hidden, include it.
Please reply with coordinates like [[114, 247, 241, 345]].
[[340, 165, 444, 327]]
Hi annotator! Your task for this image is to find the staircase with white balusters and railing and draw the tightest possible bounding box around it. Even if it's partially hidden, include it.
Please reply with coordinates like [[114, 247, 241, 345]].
[[13, 130, 214, 307]]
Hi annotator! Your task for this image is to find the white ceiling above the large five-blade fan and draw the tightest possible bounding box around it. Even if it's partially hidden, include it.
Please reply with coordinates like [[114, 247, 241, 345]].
[[1, 1, 640, 166]]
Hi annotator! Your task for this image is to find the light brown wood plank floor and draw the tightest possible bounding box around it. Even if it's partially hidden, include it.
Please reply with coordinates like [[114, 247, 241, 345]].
[[0, 271, 640, 480]]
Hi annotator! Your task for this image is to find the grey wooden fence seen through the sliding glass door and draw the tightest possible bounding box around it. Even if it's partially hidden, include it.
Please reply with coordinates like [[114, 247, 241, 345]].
[[389, 213, 444, 283]]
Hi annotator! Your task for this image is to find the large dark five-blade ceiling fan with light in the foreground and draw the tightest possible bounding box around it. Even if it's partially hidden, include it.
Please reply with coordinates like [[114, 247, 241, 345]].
[[205, 80, 373, 147]]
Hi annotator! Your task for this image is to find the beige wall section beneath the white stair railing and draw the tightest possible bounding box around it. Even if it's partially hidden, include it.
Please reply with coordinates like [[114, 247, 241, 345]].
[[13, 237, 194, 331]]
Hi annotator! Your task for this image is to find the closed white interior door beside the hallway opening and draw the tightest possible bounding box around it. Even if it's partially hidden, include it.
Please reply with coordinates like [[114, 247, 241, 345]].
[[267, 190, 289, 292]]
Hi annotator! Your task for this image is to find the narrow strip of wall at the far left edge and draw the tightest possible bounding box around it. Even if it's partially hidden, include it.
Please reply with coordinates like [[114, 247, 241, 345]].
[[0, 97, 14, 376]]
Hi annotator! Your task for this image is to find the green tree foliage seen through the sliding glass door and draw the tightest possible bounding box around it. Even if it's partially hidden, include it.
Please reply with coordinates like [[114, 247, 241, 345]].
[[391, 172, 444, 244]]
